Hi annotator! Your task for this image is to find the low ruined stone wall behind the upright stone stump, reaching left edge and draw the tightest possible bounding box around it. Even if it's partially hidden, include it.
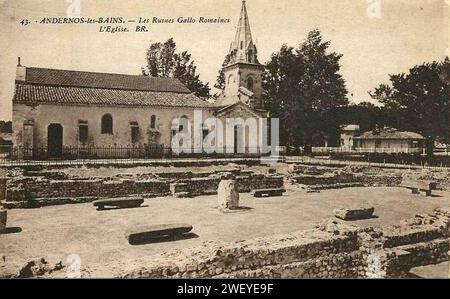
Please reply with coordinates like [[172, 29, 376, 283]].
[[0, 169, 283, 208]]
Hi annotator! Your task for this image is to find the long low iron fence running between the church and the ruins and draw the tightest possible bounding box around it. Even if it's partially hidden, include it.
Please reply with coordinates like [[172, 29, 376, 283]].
[[0, 145, 450, 167]]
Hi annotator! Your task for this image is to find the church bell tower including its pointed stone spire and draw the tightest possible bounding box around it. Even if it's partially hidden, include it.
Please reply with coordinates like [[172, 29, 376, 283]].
[[222, 1, 264, 110]]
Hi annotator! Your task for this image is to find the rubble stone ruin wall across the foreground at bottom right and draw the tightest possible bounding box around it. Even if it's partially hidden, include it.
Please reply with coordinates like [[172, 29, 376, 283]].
[[118, 209, 450, 278]]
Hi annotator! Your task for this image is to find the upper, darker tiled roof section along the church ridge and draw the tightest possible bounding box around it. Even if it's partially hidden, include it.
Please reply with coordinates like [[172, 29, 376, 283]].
[[25, 67, 190, 93]]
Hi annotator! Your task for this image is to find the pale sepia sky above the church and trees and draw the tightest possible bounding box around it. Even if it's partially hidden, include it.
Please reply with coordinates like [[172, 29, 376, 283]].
[[0, 0, 450, 120]]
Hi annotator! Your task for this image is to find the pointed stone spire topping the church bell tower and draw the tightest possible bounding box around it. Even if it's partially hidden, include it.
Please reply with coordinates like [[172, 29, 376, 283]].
[[230, 1, 258, 63]]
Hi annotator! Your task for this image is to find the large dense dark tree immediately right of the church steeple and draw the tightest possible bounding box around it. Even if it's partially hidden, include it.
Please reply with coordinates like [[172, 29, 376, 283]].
[[263, 29, 348, 149]]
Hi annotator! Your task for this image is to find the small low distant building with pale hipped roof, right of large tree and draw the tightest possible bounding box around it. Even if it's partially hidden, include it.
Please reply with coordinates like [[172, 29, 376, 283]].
[[353, 128, 425, 153]]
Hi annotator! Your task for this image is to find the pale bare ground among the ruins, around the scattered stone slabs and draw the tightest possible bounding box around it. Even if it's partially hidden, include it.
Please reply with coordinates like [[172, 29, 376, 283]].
[[0, 187, 450, 277]]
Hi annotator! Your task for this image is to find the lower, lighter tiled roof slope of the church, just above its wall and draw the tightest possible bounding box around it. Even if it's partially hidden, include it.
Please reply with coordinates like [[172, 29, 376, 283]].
[[13, 83, 213, 108]]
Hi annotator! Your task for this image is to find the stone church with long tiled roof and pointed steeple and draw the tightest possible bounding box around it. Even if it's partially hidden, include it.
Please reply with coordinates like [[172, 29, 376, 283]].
[[13, 1, 265, 158]]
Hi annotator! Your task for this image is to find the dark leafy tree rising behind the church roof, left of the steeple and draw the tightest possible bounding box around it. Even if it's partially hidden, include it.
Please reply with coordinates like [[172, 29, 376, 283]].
[[142, 38, 210, 98]]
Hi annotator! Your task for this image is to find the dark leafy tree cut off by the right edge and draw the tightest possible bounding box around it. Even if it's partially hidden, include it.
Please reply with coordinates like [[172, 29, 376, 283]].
[[370, 57, 450, 155]]
